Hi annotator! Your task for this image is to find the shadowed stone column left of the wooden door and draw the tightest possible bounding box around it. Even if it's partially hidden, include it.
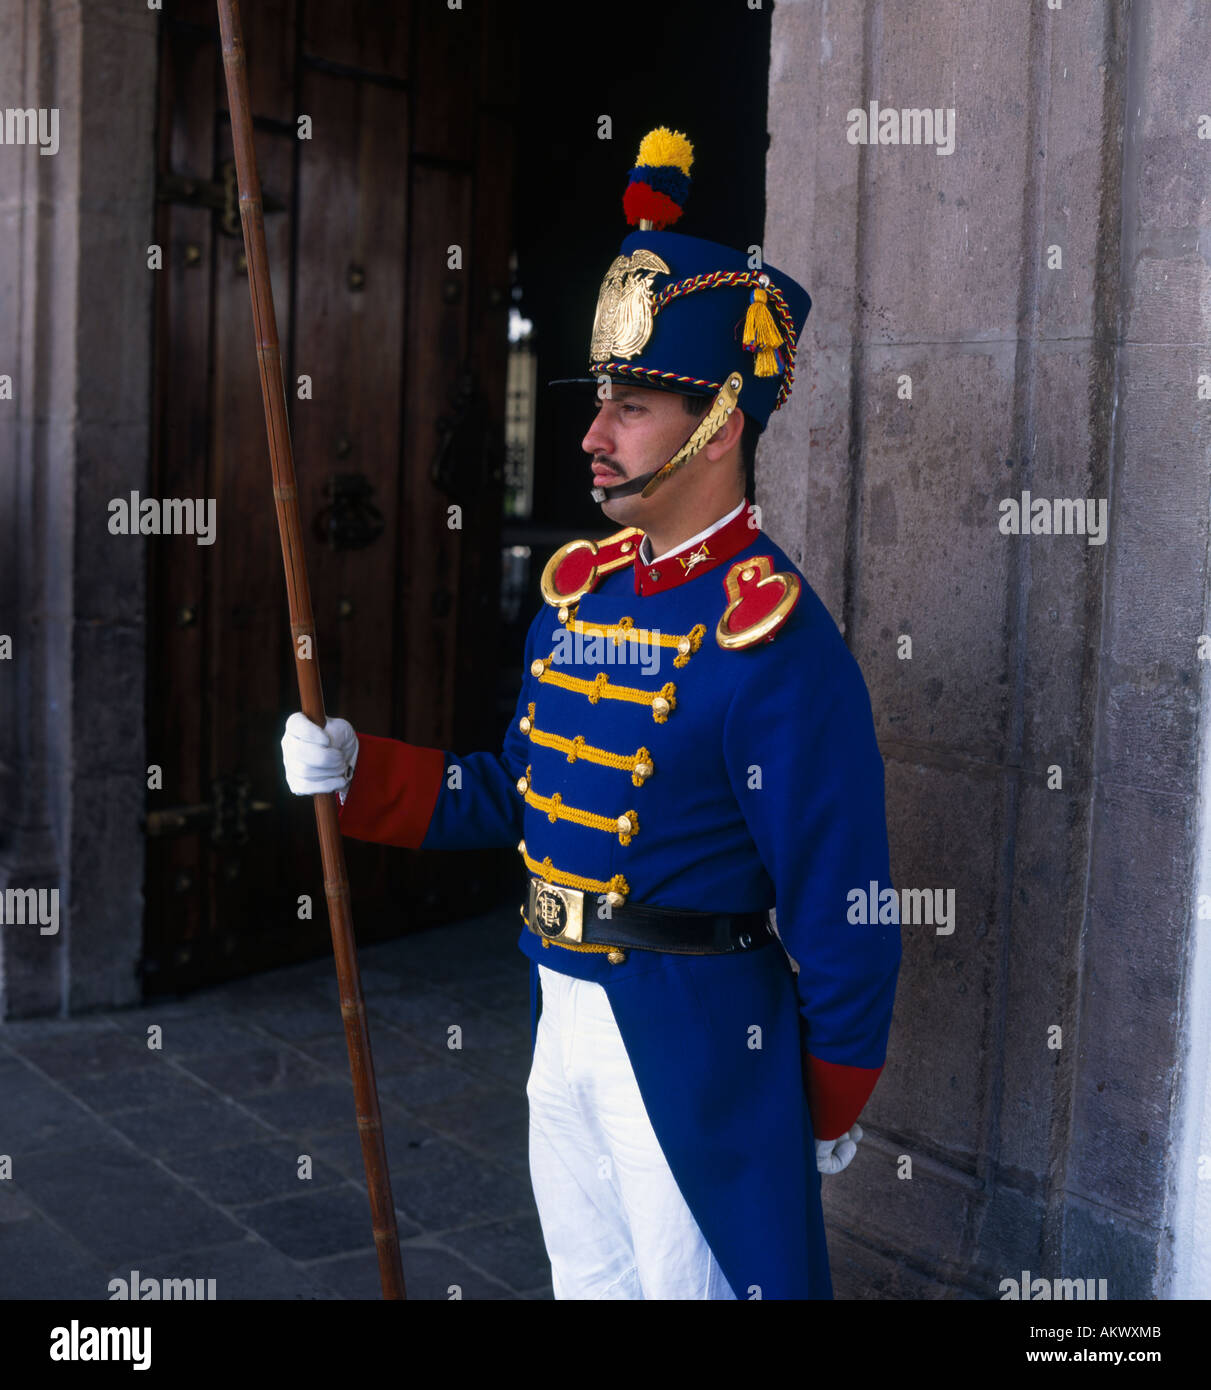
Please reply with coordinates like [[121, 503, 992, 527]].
[[0, 0, 156, 1017]]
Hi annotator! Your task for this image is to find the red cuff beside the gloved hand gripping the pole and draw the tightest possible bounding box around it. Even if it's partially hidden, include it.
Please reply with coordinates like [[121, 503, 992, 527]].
[[332, 733, 446, 849]]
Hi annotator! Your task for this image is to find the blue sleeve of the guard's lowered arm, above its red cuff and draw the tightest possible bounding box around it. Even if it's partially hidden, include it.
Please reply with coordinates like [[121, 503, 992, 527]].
[[724, 624, 901, 1068]]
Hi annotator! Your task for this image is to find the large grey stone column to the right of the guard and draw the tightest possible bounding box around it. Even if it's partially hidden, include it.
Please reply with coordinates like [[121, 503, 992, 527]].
[[758, 0, 1211, 1298]]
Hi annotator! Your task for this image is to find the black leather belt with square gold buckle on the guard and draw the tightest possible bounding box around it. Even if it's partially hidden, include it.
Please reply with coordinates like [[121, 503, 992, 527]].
[[521, 878, 777, 960]]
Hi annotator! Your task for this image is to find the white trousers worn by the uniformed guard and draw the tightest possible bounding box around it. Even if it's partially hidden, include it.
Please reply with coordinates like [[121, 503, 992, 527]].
[[526, 948, 735, 1298]]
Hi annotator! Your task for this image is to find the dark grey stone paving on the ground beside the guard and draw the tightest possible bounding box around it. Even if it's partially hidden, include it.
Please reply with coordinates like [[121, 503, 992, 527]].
[[0, 908, 552, 1300]]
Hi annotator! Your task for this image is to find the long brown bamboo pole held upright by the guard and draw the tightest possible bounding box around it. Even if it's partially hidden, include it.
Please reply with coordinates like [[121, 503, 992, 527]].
[[217, 0, 407, 1298]]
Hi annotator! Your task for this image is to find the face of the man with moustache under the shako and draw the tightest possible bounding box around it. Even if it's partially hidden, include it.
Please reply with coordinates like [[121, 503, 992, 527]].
[[581, 384, 698, 530]]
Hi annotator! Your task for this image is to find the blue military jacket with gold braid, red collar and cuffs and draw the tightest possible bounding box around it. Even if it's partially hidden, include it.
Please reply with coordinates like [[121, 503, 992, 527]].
[[342, 510, 901, 1298]]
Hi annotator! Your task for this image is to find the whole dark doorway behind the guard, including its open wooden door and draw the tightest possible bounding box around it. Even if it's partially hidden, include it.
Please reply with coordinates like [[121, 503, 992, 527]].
[[143, 0, 770, 994]]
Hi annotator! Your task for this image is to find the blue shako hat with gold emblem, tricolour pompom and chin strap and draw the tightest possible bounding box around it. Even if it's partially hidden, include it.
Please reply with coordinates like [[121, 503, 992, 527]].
[[552, 125, 812, 502]]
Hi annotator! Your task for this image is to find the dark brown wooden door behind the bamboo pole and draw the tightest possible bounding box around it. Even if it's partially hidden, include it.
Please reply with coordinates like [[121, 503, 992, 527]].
[[143, 0, 517, 994]]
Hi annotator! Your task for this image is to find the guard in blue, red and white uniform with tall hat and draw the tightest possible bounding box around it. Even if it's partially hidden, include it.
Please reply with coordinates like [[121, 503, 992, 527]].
[[282, 126, 901, 1300]]
